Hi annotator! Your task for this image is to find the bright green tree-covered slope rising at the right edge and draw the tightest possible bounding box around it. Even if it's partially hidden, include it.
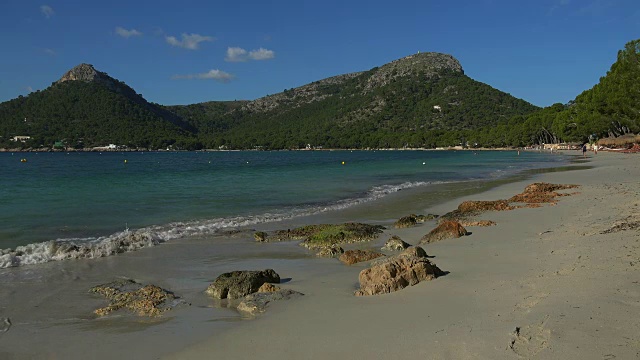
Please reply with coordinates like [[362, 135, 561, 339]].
[[464, 39, 640, 146]]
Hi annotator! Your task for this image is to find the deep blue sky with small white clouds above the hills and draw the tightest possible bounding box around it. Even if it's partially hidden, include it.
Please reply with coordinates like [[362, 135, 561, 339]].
[[0, 0, 640, 106]]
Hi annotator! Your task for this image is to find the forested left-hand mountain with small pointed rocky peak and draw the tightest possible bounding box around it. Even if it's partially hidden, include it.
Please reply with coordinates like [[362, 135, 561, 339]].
[[0, 64, 195, 149]]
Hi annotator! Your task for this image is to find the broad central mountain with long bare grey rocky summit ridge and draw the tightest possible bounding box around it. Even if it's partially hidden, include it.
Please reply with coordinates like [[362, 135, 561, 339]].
[[168, 53, 538, 149]]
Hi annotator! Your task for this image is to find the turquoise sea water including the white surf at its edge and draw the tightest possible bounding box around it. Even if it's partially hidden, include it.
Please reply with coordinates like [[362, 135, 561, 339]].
[[0, 151, 567, 267]]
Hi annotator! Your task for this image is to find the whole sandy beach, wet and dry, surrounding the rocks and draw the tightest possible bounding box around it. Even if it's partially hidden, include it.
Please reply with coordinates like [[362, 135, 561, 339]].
[[0, 152, 640, 359]]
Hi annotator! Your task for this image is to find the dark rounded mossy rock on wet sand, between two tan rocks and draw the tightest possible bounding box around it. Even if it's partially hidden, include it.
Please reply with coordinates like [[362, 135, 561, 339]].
[[206, 269, 280, 299]]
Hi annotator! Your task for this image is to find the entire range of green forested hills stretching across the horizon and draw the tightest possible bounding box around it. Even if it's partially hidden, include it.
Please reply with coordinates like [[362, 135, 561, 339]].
[[0, 40, 640, 149]]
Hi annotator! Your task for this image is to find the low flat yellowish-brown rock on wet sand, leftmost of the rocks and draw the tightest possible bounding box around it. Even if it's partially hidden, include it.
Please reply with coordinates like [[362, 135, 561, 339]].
[[89, 279, 184, 316]]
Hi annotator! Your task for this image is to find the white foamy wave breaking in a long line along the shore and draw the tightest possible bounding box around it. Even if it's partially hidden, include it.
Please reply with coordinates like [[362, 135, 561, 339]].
[[0, 182, 443, 268]]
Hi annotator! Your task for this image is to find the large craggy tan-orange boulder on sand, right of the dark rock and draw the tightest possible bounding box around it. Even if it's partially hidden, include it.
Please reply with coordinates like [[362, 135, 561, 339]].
[[355, 247, 445, 296]]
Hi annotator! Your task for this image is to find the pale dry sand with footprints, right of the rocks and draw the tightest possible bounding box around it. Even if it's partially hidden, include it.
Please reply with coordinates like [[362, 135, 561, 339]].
[[167, 152, 640, 359]]
